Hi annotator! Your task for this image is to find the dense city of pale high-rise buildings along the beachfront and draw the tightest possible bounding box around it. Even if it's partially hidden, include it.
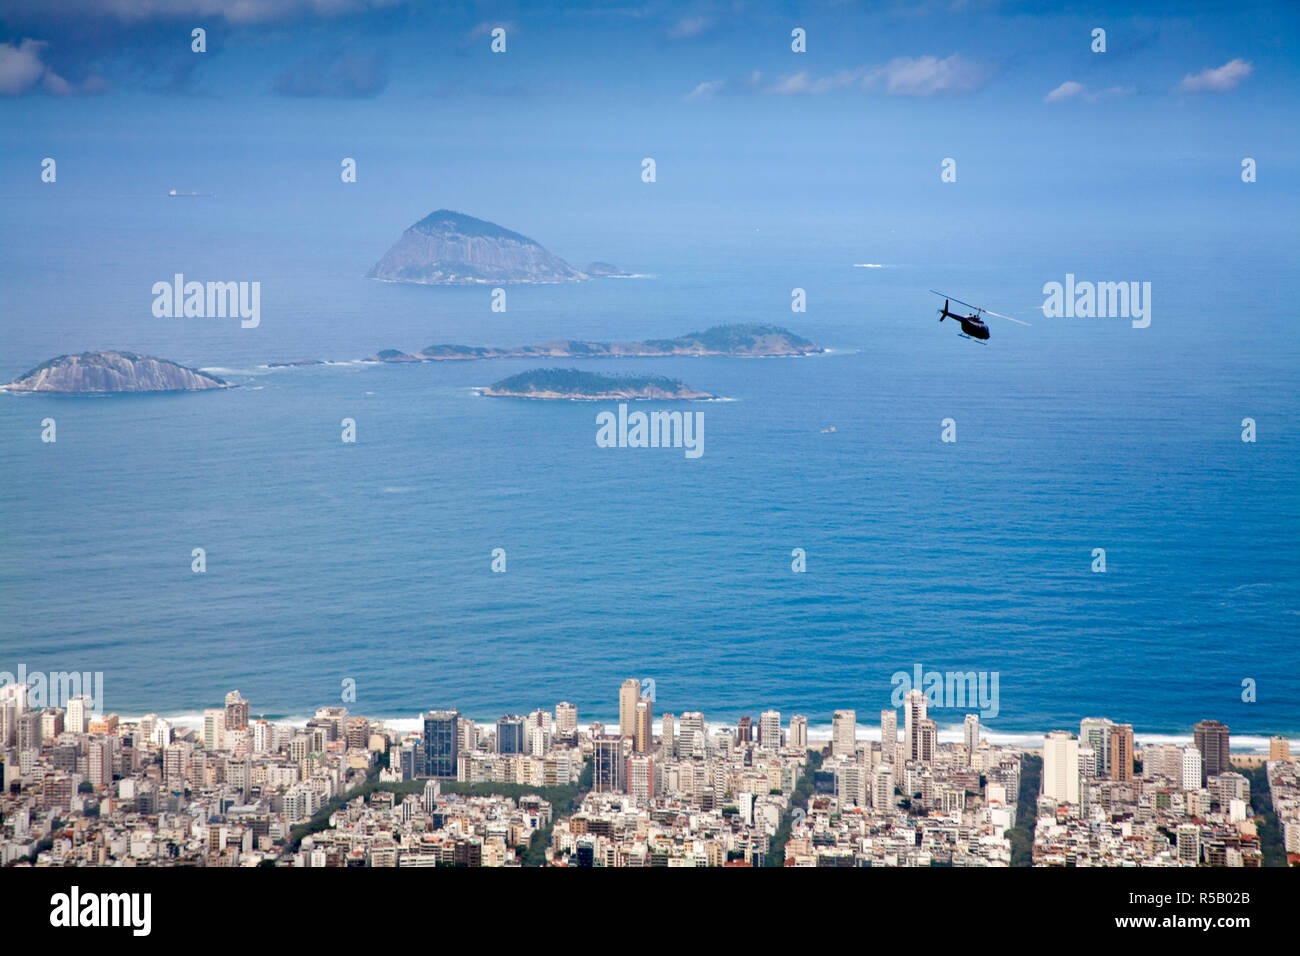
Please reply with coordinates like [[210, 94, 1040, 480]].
[[0, 679, 1300, 866]]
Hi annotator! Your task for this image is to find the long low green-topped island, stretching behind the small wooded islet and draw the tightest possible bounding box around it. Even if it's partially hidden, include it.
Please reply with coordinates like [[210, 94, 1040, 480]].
[[372, 324, 826, 362]]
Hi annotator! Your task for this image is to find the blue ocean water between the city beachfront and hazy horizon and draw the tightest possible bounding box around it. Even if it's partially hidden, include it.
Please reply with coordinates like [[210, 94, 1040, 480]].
[[0, 190, 1300, 736]]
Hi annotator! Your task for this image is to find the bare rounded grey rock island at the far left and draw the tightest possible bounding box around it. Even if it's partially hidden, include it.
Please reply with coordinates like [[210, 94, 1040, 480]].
[[0, 350, 234, 394]]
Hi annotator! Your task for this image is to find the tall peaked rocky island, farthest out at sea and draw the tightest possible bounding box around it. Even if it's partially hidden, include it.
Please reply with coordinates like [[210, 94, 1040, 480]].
[[365, 209, 588, 285]]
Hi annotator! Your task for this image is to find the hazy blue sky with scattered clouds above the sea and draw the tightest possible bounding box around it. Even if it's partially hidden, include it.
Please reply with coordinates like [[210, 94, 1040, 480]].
[[0, 0, 1300, 254]]
